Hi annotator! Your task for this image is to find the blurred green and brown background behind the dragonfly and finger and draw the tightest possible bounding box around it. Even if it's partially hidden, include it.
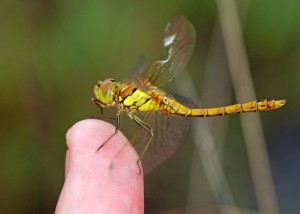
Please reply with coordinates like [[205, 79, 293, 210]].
[[0, 0, 300, 213]]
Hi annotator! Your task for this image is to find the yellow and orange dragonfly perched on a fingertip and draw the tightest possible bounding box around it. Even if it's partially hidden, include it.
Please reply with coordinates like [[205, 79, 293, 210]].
[[92, 16, 286, 174]]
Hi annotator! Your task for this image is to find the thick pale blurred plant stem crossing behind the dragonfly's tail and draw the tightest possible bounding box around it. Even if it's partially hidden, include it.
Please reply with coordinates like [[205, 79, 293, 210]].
[[217, 0, 279, 214]]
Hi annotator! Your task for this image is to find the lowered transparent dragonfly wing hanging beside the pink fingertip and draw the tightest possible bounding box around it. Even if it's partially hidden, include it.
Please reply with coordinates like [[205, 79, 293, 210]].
[[130, 111, 188, 175]]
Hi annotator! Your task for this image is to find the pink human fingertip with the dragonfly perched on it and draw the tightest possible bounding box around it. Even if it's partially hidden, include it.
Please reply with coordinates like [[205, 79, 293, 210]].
[[55, 119, 144, 214]]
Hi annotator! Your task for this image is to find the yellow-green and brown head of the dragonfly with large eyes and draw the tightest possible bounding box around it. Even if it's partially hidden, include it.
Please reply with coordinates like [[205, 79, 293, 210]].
[[92, 79, 118, 108]]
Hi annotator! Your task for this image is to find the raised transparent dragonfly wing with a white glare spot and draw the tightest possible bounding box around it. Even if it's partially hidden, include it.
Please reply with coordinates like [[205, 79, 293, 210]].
[[136, 16, 196, 87]]
